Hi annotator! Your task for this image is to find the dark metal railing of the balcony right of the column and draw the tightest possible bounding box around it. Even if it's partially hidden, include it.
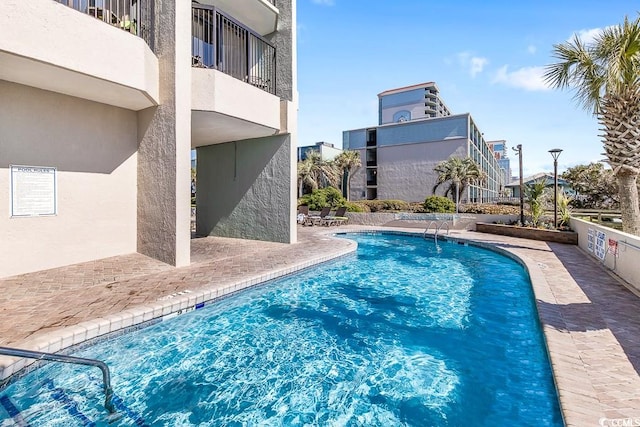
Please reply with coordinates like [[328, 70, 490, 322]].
[[191, 4, 276, 94]]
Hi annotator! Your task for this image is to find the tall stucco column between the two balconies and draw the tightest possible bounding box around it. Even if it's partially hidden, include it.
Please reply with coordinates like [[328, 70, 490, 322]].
[[137, 0, 191, 266]]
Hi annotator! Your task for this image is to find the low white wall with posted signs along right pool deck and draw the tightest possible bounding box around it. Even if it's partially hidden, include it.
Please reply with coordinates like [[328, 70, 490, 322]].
[[571, 218, 640, 291]]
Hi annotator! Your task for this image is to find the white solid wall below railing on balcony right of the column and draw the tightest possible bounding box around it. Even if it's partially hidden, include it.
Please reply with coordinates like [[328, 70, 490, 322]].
[[191, 68, 281, 147]]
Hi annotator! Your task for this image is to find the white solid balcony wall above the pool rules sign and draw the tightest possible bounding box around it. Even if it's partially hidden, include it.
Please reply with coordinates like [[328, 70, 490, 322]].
[[0, 0, 159, 111]]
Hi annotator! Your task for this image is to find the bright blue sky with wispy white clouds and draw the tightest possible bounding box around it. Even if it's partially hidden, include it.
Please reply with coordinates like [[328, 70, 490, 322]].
[[297, 0, 640, 176]]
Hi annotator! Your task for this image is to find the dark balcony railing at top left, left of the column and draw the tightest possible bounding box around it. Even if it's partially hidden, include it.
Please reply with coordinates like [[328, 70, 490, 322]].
[[54, 0, 153, 46]]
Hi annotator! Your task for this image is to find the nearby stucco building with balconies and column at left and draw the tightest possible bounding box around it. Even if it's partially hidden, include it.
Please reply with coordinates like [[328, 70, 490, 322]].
[[0, 0, 297, 277]]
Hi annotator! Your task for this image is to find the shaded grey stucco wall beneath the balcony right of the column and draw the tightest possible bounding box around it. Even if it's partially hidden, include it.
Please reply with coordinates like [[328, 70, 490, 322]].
[[196, 135, 295, 243]]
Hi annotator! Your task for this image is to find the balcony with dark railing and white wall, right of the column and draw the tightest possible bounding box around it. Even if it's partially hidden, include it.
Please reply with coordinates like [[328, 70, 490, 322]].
[[191, 0, 288, 148]]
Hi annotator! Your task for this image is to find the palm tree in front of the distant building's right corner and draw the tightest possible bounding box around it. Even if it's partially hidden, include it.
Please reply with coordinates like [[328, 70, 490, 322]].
[[432, 157, 485, 210]]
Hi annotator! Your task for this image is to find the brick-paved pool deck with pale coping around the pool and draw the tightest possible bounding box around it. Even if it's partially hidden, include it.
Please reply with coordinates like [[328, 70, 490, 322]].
[[0, 226, 640, 427]]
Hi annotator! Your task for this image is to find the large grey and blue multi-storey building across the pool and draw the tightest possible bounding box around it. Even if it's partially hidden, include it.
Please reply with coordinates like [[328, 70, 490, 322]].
[[342, 82, 504, 202]]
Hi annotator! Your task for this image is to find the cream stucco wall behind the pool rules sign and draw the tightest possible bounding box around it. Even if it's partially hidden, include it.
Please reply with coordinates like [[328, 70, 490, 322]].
[[0, 81, 137, 277]]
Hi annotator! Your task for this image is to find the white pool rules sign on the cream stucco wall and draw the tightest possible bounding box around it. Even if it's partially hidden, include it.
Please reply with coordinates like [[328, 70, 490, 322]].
[[11, 165, 57, 217]]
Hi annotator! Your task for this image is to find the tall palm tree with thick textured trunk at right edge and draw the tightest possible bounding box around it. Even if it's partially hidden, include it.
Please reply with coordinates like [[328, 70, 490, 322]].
[[545, 16, 640, 235]]
